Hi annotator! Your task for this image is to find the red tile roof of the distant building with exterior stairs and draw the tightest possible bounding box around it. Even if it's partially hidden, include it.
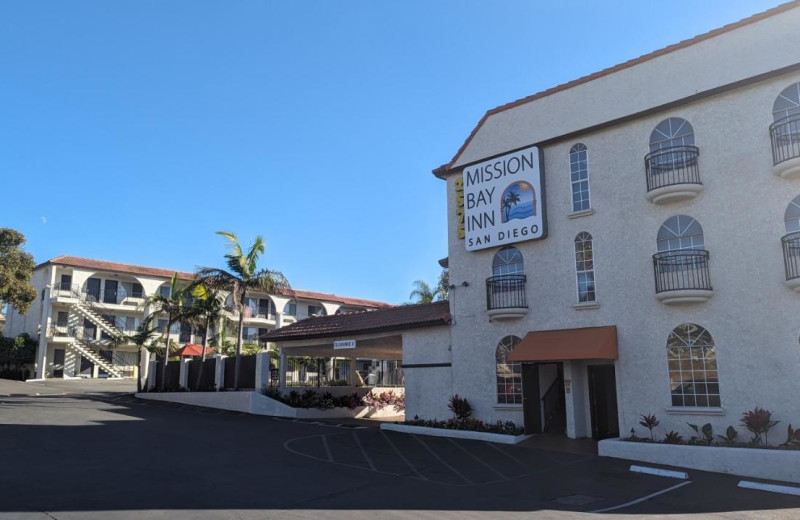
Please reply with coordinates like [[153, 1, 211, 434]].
[[36, 255, 392, 309]]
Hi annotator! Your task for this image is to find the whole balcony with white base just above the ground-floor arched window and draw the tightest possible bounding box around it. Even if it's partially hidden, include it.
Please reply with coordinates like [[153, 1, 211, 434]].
[[653, 249, 714, 304]]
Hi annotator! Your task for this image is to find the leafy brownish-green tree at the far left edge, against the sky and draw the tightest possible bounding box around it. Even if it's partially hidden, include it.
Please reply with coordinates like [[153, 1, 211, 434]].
[[0, 228, 36, 314]]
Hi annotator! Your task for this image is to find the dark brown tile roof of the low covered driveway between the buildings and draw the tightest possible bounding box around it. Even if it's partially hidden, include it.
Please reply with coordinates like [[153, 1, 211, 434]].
[[261, 301, 450, 342]]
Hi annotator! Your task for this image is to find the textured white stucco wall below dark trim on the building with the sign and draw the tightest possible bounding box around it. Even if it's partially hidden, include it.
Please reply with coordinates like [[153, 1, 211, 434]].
[[440, 68, 800, 435]]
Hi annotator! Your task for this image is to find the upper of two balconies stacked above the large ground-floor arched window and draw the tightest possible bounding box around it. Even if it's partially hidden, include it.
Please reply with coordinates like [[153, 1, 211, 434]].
[[644, 146, 703, 204]]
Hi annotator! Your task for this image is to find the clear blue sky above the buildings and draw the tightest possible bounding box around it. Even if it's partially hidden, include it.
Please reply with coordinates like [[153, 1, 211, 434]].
[[0, 0, 776, 303]]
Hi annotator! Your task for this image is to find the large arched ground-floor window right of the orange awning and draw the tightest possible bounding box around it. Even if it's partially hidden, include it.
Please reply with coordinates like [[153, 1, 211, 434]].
[[667, 323, 721, 407]]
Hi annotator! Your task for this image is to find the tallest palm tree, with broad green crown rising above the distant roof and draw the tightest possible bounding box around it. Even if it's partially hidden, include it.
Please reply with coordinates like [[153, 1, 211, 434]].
[[197, 231, 291, 390]]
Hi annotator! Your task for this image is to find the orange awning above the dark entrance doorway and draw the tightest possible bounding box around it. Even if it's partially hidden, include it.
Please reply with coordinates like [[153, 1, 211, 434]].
[[508, 325, 617, 362]]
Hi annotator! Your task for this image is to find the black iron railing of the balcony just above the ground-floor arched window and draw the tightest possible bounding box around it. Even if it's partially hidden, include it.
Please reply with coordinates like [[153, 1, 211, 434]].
[[653, 249, 711, 294]]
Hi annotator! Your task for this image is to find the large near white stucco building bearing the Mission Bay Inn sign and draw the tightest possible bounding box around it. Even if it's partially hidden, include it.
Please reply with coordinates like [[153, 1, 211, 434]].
[[412, 2, 800, 441]]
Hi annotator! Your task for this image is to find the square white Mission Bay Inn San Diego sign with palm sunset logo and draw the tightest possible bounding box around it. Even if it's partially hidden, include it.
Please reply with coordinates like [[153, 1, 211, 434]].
[[462, 146, 547, 251]]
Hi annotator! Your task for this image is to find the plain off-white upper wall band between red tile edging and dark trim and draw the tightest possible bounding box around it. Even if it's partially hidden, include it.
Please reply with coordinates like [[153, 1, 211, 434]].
[[456, 8, 800, 166]]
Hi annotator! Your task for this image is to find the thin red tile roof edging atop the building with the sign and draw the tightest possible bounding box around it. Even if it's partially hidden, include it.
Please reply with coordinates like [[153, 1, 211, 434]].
[[433, 0, 800, 177]]
